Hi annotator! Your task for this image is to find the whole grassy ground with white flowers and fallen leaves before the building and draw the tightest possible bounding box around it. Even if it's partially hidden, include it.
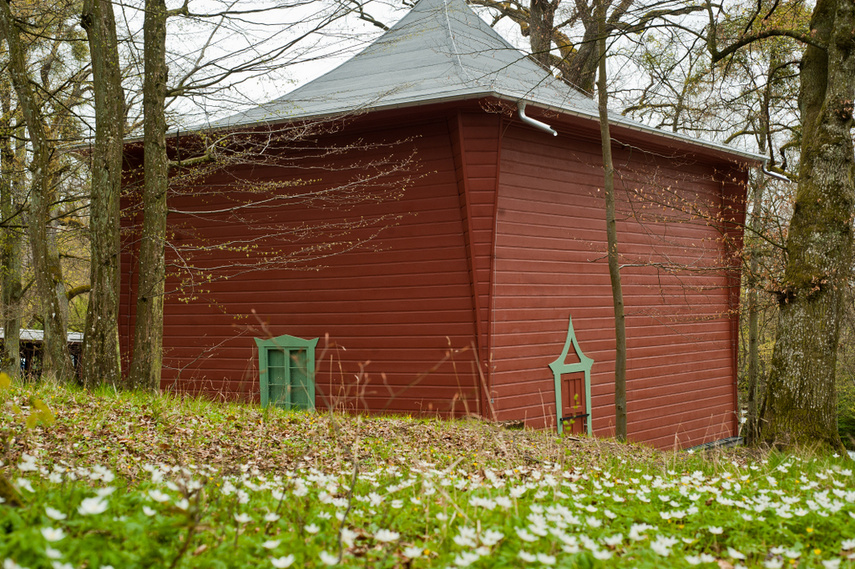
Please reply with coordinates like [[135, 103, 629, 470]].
[[0, 385, 855, 569]]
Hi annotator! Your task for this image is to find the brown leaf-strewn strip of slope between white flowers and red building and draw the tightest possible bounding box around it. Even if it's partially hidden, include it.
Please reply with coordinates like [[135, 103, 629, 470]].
[[7, 380, 661, 478]]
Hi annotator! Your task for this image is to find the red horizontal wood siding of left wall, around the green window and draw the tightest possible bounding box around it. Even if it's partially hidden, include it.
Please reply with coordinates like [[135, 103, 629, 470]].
[[122, 115, 480, 414]]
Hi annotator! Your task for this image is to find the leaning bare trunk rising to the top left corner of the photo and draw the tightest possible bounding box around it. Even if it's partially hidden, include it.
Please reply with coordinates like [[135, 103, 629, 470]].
[[0, 0, 72, 380]]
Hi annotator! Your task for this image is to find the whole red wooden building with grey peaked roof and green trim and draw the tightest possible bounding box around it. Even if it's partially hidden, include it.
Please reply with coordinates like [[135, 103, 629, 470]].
[[121, 0, 757, 446]]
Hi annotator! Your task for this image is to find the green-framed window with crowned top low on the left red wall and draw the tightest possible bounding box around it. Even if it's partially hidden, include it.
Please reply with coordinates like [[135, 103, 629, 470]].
[[255, 334, 318, 411]]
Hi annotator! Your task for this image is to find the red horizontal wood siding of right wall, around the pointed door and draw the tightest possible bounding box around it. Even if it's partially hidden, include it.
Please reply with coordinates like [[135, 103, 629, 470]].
[[492, 126, 736, 447]]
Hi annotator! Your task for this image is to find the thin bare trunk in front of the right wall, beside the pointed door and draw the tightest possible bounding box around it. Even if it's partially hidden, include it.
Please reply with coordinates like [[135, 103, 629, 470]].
[[597, 0, 627, 441]]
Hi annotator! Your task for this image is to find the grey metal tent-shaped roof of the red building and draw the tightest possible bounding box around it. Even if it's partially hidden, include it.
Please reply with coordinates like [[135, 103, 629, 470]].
[[208, 0, 763, 160]]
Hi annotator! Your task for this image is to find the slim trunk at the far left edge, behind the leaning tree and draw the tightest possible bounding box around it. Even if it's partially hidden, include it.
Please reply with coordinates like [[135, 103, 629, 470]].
[[0, 85, 23, 377]]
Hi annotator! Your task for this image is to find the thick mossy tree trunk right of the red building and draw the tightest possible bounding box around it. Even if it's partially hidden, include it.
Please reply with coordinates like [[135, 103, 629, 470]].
[[760, 0, 855, 450]]
